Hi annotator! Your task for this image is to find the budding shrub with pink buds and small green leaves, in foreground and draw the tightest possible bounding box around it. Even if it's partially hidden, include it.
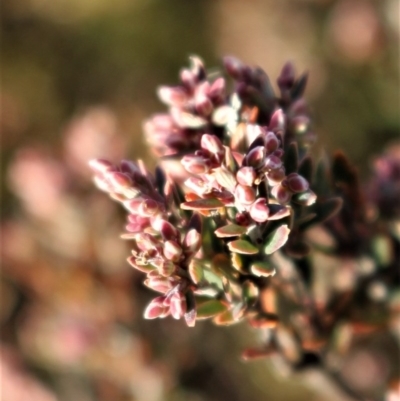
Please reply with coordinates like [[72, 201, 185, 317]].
[[90, 57, 400, 396]]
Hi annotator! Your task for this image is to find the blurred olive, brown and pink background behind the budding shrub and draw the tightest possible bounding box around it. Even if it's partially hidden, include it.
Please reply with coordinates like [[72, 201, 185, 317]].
[[0, 0, 400, 401]]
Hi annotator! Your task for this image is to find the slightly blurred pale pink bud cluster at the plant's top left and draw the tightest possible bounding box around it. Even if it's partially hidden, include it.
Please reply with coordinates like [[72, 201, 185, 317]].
[[144, 57, 226, 155]]
